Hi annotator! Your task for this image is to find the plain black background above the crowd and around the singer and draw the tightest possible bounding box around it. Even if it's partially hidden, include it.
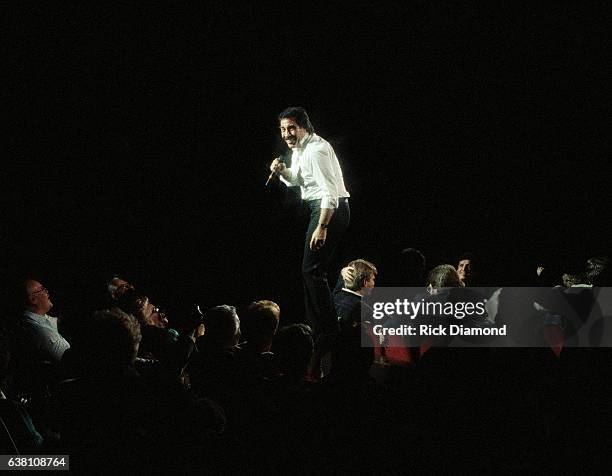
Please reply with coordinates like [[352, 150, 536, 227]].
[[1, 1, 610, 319]]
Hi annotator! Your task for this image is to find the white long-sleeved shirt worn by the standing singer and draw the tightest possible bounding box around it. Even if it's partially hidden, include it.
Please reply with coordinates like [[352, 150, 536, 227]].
[[281, 134, 350, 209]]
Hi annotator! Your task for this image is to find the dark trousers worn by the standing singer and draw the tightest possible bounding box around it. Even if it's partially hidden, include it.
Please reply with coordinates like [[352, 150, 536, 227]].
[[302, 198, 351, 350]]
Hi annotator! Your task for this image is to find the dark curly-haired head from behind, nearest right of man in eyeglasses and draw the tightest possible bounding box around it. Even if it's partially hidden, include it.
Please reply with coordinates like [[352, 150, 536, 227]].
[[83, 307, 141, 370]]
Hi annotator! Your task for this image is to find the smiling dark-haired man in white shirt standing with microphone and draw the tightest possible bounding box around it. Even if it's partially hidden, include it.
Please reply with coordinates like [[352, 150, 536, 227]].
[[270, 107, 350, 352]]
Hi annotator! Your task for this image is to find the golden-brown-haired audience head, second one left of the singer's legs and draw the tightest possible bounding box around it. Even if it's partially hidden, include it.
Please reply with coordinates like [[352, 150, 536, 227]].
[[240, 300, 280, 352]]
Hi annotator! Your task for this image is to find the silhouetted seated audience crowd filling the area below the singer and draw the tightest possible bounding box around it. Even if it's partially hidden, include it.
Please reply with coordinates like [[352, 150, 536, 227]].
[[0, 255, 612, 473]]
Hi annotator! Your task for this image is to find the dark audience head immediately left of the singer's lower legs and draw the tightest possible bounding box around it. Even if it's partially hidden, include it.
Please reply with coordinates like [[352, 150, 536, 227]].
[[273, 324, 314, 378]]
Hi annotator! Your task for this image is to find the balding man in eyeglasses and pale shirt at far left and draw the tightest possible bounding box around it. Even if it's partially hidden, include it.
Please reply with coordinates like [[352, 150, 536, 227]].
[[21, 279, 70, 363]]
